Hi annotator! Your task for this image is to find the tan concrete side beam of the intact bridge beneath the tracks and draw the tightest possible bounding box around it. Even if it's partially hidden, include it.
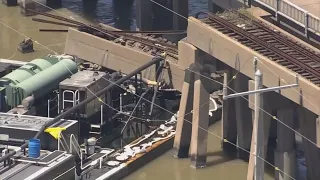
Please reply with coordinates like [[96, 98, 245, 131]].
[[187, 17, 320, 114]]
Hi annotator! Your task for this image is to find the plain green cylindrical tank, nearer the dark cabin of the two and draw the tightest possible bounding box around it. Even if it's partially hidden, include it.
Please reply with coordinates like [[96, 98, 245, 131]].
[[15, 59, 78, 105]]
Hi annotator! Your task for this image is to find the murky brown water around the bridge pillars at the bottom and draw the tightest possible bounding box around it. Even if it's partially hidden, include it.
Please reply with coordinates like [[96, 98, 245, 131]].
[[125, 122, 274, 180]]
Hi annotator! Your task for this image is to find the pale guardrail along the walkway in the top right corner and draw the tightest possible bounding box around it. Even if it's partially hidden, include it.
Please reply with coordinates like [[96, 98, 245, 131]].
[[254, 0, 320, 37]]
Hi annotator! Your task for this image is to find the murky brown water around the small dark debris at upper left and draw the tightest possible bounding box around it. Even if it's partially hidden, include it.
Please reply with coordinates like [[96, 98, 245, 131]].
[[0, 4, 67, 61]]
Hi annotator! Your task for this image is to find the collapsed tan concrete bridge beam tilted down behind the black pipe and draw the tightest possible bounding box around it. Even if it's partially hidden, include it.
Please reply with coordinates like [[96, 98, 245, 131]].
[[65, 28, 188, 91]]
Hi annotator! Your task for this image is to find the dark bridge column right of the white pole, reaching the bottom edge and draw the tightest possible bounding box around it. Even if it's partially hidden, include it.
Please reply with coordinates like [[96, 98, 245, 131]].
[[275, 108, 296, 180]]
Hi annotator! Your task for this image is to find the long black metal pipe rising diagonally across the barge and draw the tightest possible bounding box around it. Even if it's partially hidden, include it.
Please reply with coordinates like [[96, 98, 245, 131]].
[[0, 56, 164, 163]]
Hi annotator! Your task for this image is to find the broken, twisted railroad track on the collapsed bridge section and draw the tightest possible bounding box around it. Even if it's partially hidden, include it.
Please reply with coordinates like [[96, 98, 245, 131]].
[[28, 10, 178, 59]]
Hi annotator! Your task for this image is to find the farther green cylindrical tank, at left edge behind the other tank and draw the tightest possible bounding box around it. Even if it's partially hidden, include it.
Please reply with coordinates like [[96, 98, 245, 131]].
[[0, 57, 59, 85]]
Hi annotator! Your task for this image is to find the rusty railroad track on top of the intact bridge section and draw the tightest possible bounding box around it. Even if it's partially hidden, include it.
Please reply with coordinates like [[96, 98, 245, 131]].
[[201, 11, 320, 86]]
